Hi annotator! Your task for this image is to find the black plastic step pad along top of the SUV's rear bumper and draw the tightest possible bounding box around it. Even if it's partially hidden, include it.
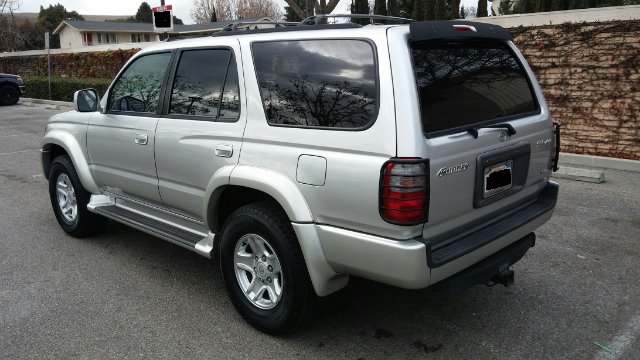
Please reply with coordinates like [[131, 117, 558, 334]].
[[425, 182, 558, 268]]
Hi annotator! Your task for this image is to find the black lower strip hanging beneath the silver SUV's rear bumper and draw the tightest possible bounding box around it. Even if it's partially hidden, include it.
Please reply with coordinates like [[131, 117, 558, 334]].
[[432, 233, 536, 295]]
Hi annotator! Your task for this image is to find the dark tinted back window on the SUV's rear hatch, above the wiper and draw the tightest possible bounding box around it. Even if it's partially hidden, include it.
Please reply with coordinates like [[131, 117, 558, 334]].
[[412, 41, 537, 134]]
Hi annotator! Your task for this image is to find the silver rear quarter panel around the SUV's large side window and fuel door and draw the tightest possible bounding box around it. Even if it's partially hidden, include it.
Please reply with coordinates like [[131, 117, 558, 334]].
[[240, 29, 420, 238]]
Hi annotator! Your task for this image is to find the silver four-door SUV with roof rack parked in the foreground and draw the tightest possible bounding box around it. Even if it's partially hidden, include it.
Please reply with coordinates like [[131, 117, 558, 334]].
[[42, 16, 559, 334]]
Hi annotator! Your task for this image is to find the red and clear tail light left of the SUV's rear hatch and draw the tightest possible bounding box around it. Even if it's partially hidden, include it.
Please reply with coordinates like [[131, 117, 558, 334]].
[[380, 158, 429, 225]]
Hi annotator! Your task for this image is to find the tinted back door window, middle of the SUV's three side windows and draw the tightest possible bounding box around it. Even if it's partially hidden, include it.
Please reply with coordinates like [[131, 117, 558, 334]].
[[169, 50, 240, 120]]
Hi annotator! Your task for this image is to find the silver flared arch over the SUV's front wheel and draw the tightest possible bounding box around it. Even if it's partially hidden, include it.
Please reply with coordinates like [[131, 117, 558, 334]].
[[41, 130, 100, 194]]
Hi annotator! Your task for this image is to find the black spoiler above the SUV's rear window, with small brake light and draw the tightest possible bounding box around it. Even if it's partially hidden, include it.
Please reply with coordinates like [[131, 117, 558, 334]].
[[409, 21, 513, 43]]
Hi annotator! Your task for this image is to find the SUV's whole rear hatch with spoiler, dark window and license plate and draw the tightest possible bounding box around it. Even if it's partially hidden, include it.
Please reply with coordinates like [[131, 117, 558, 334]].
[[410, 22, 553, 248]]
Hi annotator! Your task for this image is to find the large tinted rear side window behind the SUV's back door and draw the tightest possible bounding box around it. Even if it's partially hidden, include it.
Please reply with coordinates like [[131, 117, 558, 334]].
[[253, 40, 378, 128]]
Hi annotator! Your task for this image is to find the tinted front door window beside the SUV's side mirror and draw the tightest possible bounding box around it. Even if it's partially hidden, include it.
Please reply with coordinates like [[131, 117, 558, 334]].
[[107, 53, 171, 113]]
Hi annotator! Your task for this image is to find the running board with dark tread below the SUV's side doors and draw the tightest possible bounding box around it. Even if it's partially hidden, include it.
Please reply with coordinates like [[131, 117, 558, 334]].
[[87, 195, 214, 258]]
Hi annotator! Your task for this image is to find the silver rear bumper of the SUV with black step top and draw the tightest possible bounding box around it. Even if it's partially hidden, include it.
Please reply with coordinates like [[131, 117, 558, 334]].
[[316, 182, 558, 289]]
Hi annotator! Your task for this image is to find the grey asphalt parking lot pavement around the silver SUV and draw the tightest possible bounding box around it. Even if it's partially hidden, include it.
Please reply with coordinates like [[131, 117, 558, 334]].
[[0, 105, 640, 359]]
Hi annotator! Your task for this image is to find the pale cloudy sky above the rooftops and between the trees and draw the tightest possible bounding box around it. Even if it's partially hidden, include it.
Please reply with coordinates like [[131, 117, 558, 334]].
[[17, 0, 477, 24]]
